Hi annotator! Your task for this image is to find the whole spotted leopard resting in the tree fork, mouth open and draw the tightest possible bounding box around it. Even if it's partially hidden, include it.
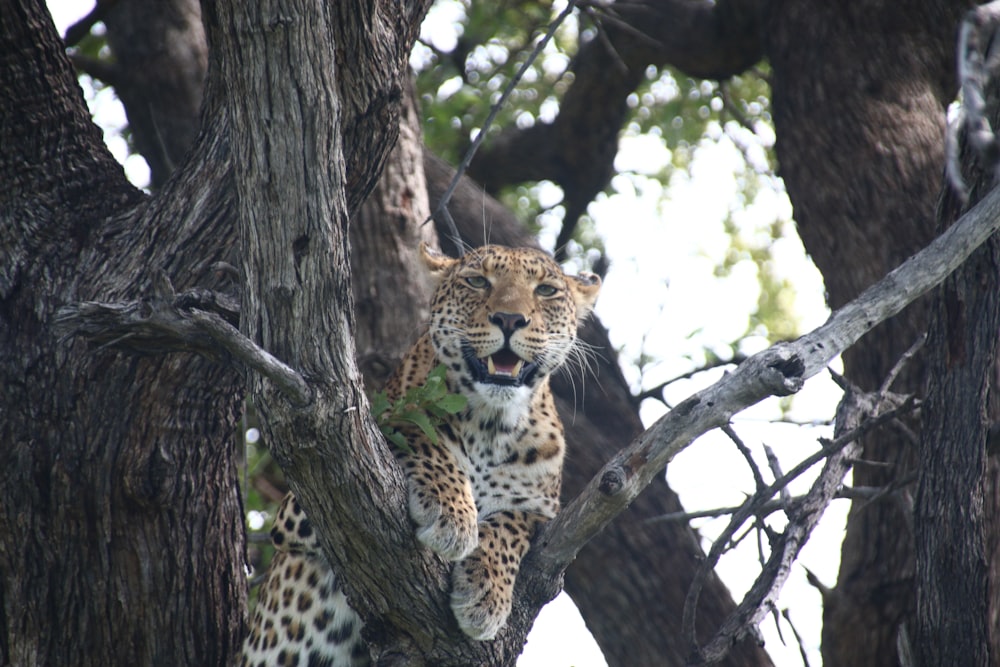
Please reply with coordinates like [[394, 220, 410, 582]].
[[242, 243, 601, 667]]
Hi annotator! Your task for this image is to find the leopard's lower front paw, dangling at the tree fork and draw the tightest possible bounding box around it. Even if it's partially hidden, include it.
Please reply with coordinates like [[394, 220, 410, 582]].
[[451, 551, 514, 641]]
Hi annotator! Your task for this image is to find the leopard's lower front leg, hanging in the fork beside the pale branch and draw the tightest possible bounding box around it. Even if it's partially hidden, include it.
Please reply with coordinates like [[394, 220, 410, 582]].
[[451, 510, 547, 640]]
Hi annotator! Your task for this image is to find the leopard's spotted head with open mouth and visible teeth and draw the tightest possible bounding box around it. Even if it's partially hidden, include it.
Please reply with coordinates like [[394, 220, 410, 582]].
[[421, 246, 601, 401]]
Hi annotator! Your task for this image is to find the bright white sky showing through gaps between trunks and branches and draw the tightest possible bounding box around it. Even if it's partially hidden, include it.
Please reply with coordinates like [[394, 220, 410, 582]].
[[49, 0, 850, 667]]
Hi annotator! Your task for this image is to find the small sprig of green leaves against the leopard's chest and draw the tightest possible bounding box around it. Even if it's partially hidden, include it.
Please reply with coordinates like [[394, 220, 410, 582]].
[[372, 364, 468, 453]]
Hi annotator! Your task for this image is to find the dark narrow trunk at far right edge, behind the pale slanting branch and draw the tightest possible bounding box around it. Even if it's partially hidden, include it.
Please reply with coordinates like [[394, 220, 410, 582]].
[[909, 70, 1000, 667]]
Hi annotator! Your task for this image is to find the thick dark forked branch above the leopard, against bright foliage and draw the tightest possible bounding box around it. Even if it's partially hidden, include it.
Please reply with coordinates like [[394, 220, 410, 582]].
[[469, 0, 763, 259]]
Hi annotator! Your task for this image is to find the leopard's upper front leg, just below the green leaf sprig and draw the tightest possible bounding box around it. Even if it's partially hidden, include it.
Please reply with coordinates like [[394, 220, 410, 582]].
[[397, 434, 479, 561]]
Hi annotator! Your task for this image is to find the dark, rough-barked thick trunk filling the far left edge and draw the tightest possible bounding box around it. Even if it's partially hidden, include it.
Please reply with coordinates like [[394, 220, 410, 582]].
[[0, 2, 245, 666]]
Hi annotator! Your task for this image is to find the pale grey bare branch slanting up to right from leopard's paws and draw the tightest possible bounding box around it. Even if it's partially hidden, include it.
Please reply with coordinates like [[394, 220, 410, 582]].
[[530, 180, 1000, 624]]
